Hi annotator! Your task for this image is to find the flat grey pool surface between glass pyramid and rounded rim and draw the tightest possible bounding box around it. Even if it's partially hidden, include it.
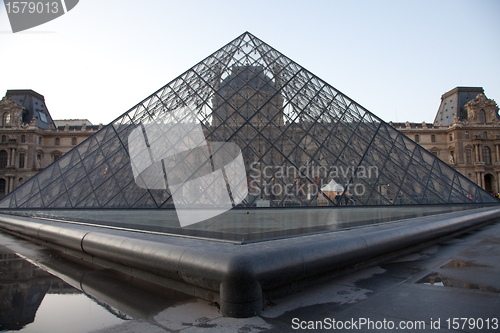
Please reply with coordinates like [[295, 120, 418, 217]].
[[0, 204, 488, 244]]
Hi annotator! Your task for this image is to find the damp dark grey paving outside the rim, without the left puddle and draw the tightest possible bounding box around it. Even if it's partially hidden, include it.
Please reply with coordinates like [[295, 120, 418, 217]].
[[0, 222, 500, 333]]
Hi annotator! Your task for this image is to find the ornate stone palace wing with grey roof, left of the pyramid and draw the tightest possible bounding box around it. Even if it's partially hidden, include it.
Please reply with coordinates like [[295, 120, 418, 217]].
[[0, 90, 102, 197]]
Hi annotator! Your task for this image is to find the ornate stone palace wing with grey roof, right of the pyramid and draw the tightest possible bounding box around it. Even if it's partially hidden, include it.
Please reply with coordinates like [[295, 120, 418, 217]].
[[392, 87, 500, 194]]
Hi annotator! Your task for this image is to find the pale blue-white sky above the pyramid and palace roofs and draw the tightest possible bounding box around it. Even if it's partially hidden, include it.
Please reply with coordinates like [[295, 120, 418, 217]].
[[0, 0, 500, 124]]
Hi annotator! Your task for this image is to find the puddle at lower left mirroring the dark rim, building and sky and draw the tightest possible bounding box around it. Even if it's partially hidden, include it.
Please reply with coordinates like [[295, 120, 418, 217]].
[[0, 240, 192, 332]]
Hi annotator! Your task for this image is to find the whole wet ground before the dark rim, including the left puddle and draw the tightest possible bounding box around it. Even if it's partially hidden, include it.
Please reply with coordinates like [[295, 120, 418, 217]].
[[0, 222, 500, 333]]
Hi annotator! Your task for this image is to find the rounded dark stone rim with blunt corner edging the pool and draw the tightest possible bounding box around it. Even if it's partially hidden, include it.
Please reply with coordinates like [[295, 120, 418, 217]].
[[0, 207, 500, 318]]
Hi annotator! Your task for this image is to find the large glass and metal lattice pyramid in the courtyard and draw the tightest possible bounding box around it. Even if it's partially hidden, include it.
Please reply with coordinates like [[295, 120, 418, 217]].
[[0, 32, 498, 213]]
